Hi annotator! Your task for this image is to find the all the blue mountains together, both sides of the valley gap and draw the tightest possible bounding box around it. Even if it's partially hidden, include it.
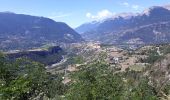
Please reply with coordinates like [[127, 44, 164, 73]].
[[0, 6, 170, 50]]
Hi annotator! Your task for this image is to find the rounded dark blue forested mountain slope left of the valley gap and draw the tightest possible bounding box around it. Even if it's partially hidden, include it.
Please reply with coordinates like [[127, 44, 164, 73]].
[[0, 12, 83, 49]]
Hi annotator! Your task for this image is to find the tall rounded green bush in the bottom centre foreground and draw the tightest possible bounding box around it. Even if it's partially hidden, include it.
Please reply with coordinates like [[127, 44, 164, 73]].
[[67, 62, 122, 100]]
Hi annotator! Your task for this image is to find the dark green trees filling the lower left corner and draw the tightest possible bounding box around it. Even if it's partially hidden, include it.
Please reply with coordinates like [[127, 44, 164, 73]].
[[0, 53, 63, 100]]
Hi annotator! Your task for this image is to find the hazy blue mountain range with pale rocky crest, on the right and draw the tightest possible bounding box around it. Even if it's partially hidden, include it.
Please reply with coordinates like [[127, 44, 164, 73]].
[[75, 6, 170, 44]]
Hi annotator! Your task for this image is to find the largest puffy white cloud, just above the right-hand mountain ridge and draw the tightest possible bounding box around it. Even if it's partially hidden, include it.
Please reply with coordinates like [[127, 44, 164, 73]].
[[86, 9, 115, 20]]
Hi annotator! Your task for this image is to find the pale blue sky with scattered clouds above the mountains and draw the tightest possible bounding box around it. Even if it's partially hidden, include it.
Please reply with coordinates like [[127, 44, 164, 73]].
[[0, 0, 170, 28]]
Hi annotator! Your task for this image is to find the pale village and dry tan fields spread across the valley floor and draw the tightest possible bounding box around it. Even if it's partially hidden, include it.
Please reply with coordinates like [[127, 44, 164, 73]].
[[45, 42, 157, 84]]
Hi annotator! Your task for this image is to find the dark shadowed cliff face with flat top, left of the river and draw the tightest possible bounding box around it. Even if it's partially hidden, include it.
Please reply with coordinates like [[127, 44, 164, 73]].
[[7, 46, 65, 65]]
